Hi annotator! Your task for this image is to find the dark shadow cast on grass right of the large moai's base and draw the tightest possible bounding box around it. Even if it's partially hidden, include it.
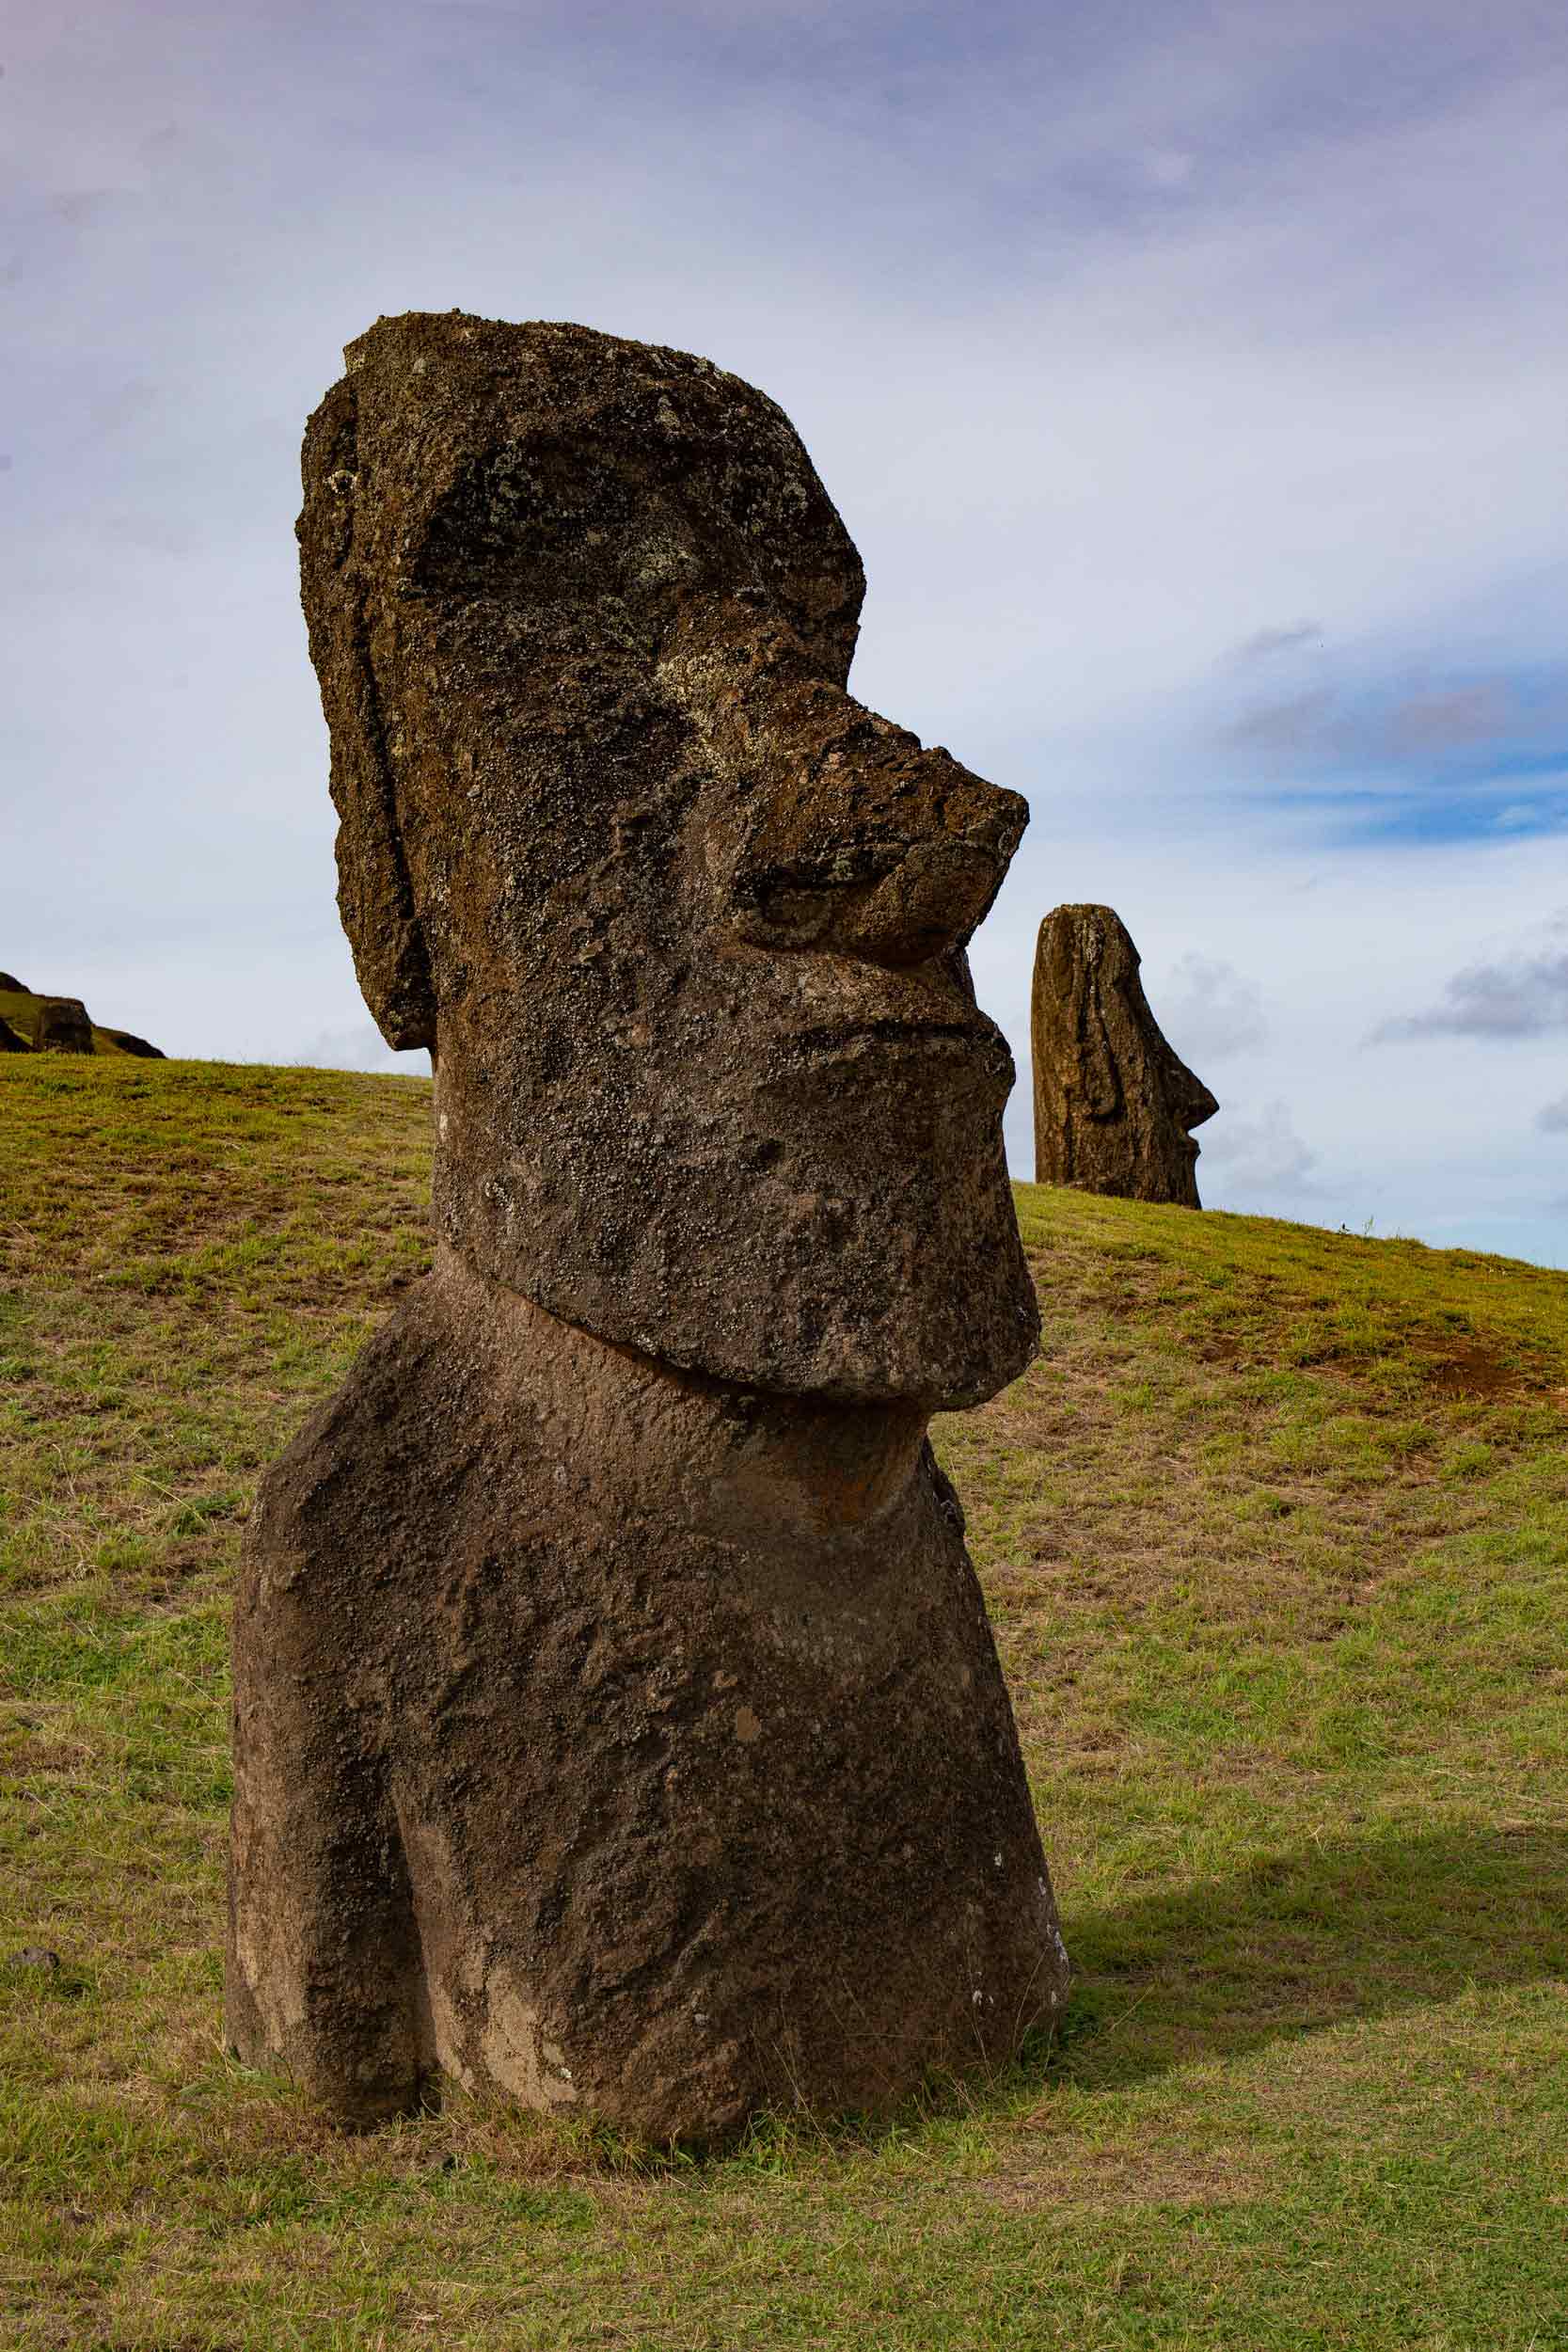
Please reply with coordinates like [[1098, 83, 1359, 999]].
[[1030, 1823, 1568, 2089]]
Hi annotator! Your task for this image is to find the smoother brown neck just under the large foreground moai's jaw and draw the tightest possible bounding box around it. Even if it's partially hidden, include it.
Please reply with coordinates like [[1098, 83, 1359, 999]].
[[433, 1242, 931, 1548]]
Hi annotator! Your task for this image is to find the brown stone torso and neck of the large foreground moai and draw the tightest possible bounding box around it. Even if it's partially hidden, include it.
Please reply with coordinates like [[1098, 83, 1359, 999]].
[[228, 1249, 1068, 2140]]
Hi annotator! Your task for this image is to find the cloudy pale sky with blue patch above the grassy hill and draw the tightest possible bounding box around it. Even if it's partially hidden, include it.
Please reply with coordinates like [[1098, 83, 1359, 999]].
[[0, 0, 1568, 1265]]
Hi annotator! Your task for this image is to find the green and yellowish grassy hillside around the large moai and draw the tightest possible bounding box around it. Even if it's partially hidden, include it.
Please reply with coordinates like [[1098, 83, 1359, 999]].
[[0, 1057, 1568, 2352]]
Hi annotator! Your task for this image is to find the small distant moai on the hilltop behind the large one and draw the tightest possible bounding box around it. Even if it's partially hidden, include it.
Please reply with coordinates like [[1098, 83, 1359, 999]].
[[1030, 906, 1220, 1209]]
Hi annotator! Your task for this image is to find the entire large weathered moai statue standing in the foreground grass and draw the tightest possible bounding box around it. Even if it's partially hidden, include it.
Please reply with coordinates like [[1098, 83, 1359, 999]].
[[228, 313, 1068, 2143]]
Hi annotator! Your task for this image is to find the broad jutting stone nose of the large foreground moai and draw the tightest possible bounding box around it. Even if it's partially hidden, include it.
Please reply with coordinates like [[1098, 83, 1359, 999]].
[[729, 687, 1030, 964]]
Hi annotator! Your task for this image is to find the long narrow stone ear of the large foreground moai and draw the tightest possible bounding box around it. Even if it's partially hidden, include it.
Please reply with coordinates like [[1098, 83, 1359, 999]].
[[298, 376, 435, 1052]]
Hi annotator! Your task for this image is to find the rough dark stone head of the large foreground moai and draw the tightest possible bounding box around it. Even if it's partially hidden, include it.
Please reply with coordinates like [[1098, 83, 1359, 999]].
[[298, 313, 1037, 1405]]
